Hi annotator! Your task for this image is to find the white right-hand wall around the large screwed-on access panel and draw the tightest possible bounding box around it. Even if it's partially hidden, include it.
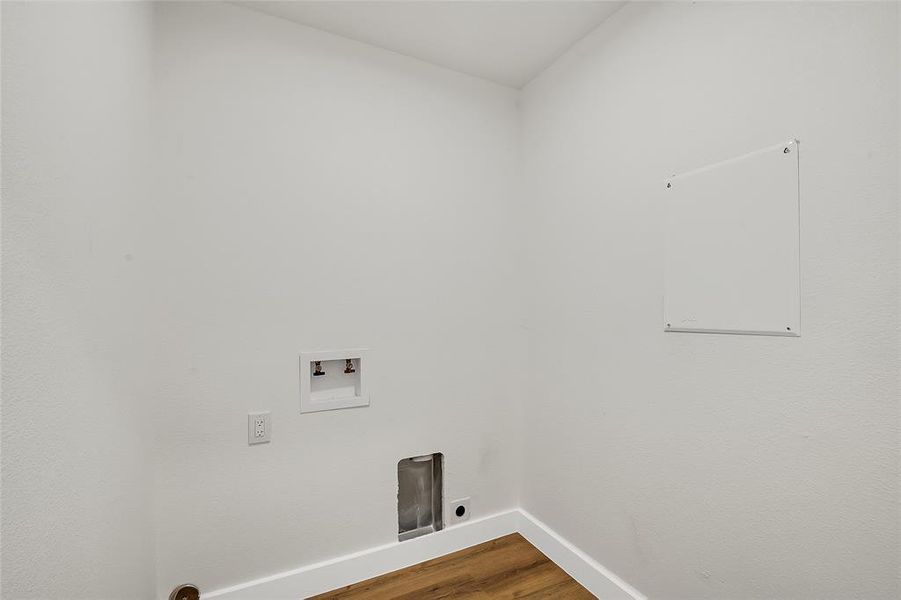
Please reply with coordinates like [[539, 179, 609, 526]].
[[523, 3, 901, 599]]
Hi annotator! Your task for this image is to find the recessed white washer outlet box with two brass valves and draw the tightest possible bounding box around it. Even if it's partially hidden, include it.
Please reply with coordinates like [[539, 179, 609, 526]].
[[300, 348, 369, 413]]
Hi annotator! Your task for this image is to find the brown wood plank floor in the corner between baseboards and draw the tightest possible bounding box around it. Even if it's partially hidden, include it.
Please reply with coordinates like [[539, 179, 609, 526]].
[[311, 533, 594, 600]]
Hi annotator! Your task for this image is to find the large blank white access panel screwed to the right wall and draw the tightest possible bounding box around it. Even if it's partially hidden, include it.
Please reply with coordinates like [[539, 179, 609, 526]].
[[661, 140, 801, 336]]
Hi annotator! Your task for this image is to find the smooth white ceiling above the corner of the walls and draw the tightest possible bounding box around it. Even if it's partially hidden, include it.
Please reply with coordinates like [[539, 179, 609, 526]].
[[236, 0, 625, 88]]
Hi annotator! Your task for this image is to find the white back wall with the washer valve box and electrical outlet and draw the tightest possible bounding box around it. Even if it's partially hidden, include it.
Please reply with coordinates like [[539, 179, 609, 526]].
[[146, 3, 525, 595]]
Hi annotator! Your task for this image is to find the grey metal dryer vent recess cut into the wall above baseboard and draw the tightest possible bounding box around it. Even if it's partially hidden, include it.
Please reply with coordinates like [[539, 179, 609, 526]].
[[397, 452, 444, 541]]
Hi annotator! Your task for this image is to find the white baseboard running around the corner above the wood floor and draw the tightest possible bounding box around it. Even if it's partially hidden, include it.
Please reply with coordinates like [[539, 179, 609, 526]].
[[203, 509, 647, 600]]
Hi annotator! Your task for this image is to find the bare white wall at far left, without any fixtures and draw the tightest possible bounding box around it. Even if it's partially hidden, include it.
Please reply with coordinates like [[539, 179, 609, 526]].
[[0, 2, 154, 600]]
